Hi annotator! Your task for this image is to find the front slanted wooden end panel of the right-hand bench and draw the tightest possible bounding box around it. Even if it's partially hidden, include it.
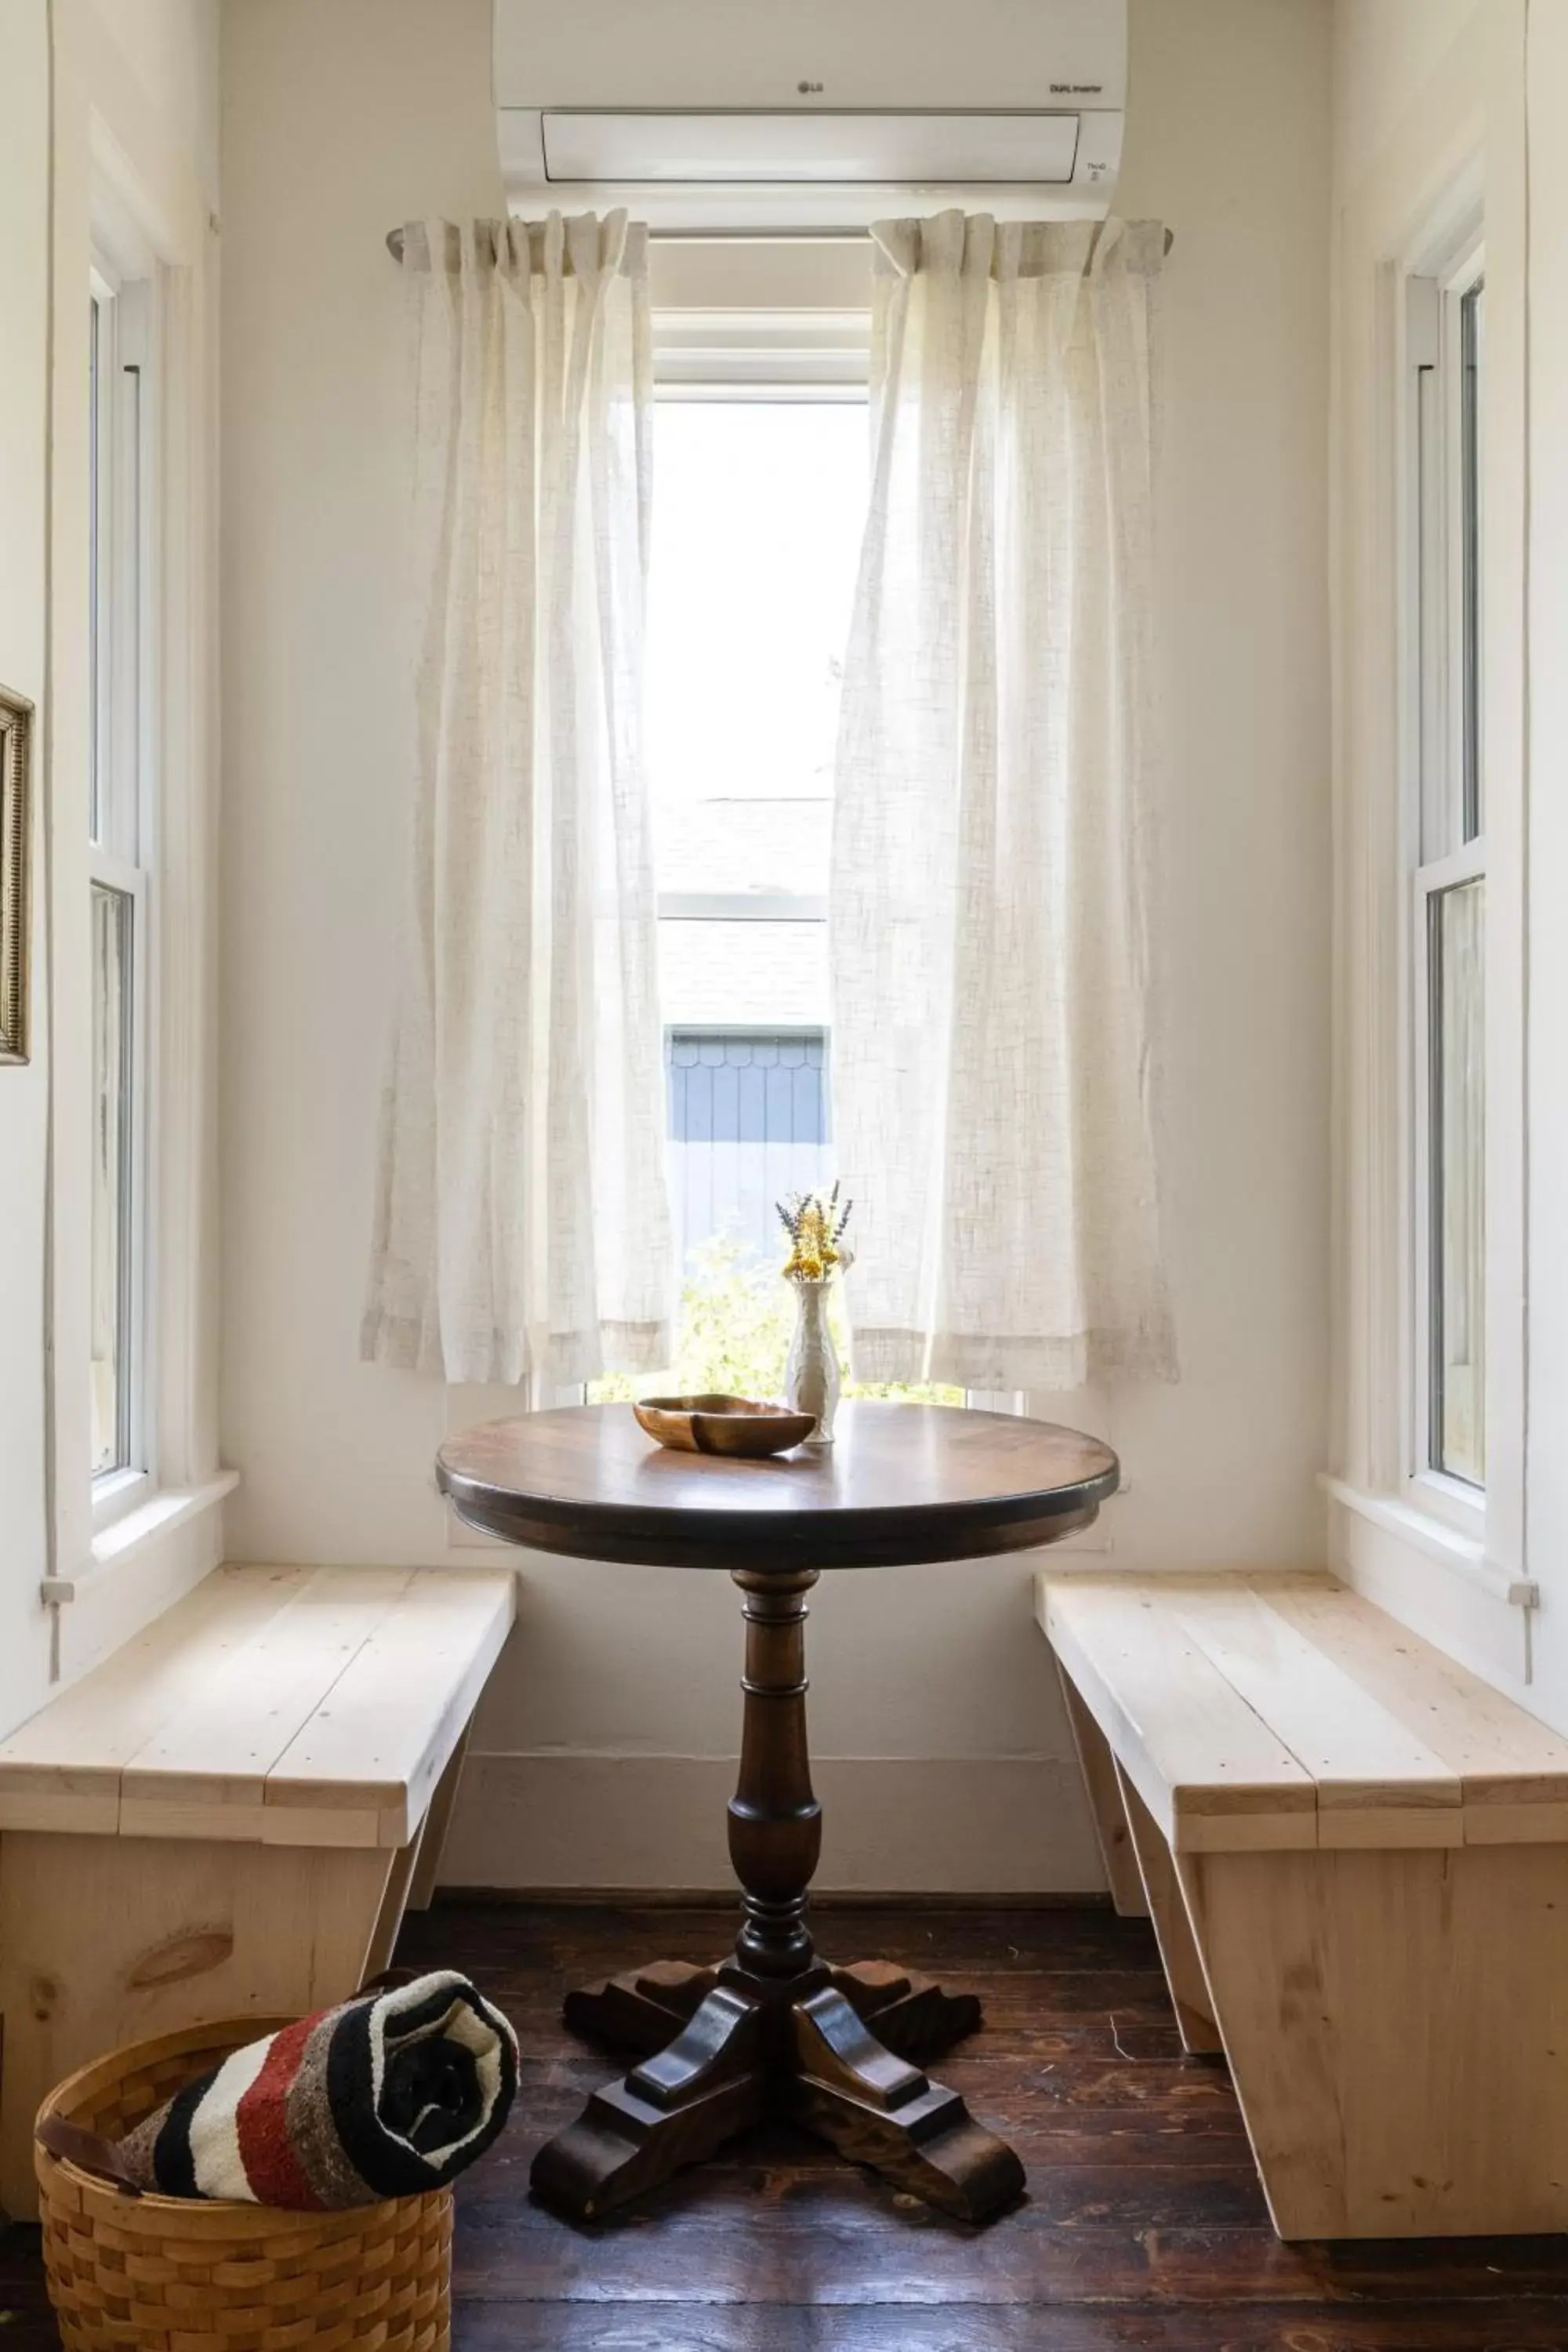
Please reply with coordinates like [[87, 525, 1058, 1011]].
[[1178, 1846, 1568, 2239]]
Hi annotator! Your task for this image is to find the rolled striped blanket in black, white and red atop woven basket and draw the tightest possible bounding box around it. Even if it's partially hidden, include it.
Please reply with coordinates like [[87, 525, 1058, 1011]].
[[118, 1969, 517, 2213]]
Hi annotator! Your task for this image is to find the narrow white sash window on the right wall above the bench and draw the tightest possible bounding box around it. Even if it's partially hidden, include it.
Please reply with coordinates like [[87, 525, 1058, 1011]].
[[1408, 249, 1486, 1491]]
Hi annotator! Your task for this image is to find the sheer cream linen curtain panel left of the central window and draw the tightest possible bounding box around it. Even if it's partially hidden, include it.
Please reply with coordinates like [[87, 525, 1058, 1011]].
[[362, 212, 673, 1399]]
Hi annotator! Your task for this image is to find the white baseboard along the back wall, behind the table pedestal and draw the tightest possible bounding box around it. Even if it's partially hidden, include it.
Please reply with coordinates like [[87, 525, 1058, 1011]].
[[442, 1755, 1105, 1898]]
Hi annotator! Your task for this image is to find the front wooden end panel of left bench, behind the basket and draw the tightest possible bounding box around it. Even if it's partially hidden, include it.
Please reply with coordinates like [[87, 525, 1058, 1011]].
[[0, 1830, 400, 2220]]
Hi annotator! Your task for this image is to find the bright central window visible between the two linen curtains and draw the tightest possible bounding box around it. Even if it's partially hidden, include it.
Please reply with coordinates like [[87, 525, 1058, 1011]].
[[595, 386, 961, 1402]]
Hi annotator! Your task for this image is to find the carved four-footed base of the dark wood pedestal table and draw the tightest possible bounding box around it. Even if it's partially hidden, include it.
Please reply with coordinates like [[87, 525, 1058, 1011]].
[[534, 1962, 1022, 2220]]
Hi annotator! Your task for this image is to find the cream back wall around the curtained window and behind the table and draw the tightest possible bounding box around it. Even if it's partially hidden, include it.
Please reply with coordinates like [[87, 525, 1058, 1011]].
[[223, 0, 1328, 1889]]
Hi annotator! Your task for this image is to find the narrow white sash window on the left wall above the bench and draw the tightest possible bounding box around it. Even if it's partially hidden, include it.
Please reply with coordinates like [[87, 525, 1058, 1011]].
[[85, 266, 153, 1515]]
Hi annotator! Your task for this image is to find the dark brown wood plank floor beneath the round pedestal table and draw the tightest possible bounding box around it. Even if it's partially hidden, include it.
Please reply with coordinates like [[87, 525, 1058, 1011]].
[[0, 1903, 1568, 2352]]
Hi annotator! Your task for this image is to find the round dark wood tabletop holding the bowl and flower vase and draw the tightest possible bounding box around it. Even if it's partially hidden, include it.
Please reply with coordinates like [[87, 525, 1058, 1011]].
[[437, 1399, 1119, 1571]]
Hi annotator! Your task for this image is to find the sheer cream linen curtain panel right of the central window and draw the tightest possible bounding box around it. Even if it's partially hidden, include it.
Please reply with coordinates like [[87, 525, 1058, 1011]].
[[829, 212, 1175, 1392]]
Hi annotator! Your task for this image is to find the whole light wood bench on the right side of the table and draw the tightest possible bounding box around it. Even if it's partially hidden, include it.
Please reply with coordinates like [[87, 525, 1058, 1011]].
[[1036, 1571, 1568, 2239]]
